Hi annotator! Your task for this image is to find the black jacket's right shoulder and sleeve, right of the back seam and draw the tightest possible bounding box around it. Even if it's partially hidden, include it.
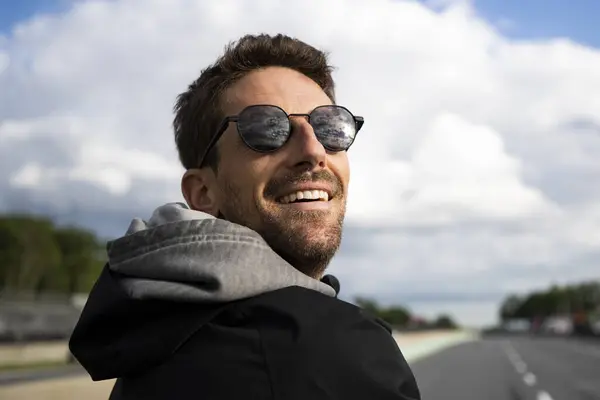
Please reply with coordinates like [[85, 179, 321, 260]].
[[240, 287, 420, 400]]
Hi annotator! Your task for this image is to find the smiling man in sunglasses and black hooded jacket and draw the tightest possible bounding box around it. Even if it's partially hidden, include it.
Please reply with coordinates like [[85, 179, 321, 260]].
[[70, 35, 420, 400]]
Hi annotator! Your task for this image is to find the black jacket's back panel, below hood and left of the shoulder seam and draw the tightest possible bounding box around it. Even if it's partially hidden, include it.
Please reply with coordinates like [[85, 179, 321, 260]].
[[110, 309, 273, 400]]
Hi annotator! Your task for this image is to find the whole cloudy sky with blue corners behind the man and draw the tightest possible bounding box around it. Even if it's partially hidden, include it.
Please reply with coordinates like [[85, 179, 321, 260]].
[[0, 0, 600, 326]]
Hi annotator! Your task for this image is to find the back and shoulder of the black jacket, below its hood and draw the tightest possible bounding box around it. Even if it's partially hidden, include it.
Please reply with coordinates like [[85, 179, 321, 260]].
[[111, 287, 420, 400]]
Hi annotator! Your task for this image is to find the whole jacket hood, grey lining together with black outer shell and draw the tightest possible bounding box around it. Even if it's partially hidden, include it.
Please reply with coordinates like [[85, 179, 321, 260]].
[[69, 203, 339, 380]]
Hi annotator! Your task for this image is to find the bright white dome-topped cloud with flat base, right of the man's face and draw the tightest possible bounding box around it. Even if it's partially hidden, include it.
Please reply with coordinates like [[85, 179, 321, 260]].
[[349, 113, 554, 226]]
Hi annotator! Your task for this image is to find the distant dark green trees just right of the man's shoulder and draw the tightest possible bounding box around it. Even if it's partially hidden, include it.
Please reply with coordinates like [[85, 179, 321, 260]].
[[353, 297, 458, 329]]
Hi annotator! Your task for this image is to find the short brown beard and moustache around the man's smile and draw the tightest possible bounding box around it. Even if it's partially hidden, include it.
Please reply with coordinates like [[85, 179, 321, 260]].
[[219, 172, 346, 279]]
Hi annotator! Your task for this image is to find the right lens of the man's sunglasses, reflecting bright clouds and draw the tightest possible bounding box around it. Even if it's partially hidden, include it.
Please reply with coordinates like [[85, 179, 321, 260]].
[[310, 106, 356, 151]]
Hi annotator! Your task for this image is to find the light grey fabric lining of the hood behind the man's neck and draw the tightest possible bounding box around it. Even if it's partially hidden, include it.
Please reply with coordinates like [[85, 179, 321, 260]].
[[108, 203, 336, 302]]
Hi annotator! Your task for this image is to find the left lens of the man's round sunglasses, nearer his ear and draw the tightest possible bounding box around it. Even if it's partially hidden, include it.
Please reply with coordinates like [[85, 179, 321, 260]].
[[237, 105, 290, 152]]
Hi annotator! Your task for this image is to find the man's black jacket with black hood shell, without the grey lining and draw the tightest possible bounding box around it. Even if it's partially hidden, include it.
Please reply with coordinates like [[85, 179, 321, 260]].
[[70, 205, 420, 400]]
